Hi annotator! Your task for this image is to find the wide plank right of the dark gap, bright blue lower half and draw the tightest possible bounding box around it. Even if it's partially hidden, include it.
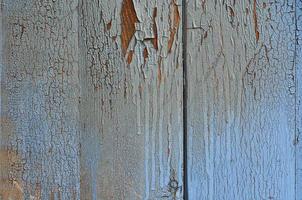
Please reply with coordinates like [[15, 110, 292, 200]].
[[186, 0, 301, 200]]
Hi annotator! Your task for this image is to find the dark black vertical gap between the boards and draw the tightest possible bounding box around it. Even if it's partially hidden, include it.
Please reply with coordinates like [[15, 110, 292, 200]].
[[182, 0, 189, 200]]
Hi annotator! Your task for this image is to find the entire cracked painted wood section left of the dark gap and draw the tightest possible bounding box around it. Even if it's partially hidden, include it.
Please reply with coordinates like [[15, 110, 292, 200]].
[[0, 0, 183, 199]]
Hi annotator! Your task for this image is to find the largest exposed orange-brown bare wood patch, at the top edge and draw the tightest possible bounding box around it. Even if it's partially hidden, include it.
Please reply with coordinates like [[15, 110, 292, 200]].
[[121, 0, 138, 55]]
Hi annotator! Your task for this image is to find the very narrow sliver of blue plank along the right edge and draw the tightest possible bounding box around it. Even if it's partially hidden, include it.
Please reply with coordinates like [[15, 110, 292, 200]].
[[295, 0, 302, 200]]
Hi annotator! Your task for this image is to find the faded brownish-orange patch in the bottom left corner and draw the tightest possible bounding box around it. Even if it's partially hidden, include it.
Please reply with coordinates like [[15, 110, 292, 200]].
[[0, 149, 23, 200]]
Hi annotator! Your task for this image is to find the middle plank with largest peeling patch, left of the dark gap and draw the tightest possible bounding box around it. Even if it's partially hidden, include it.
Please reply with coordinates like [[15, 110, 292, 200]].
[[79, 0, 183, 199]]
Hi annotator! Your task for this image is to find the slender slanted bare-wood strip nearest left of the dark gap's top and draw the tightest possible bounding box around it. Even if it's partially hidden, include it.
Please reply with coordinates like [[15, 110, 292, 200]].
[[168, 2, 180, 53]]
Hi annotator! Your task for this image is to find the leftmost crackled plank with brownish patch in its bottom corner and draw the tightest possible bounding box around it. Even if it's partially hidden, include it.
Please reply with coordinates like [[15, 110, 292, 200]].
[[0, 0, 80, 199]]
